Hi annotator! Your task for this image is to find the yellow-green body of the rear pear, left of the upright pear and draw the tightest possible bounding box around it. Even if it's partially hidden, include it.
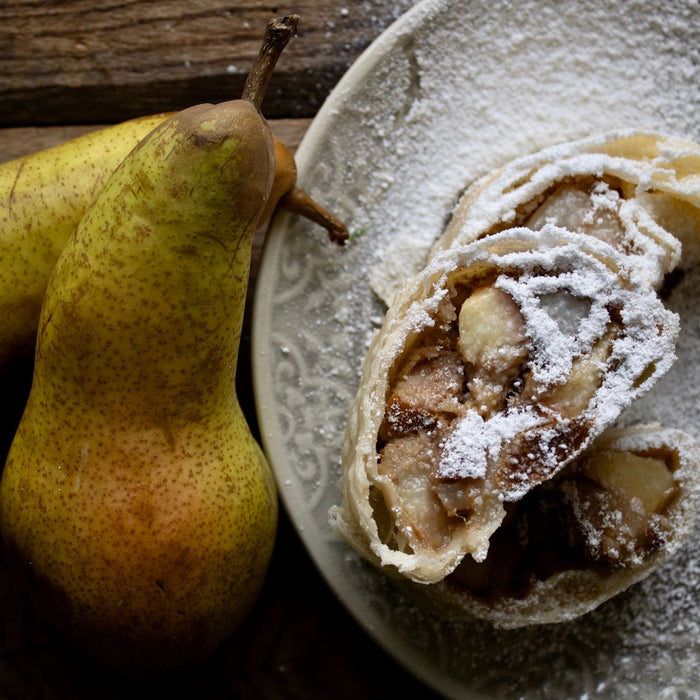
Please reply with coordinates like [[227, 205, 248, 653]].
[[0, 114, 166, 372]]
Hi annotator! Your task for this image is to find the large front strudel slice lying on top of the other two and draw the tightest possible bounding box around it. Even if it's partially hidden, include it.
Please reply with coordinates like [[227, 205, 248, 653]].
[[331, 228, 678, 583]]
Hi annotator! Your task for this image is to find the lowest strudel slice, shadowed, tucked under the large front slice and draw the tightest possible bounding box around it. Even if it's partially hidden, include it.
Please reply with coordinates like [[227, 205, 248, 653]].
[[411, 425, 700, 628]]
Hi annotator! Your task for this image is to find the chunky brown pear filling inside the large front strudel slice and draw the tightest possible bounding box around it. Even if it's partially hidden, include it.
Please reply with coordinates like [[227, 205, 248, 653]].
[[374, 266, 621, 558]]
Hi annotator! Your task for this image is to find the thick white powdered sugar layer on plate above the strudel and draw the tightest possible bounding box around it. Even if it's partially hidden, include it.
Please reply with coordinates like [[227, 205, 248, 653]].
[[350, 1, 700, 298]]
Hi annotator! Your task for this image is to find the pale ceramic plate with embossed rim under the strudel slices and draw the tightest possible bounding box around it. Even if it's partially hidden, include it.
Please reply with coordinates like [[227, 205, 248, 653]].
[[253, 0, 700, 699]]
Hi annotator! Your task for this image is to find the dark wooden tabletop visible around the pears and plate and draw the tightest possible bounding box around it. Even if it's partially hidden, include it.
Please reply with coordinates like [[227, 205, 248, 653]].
[[0, 0, 442, 700]]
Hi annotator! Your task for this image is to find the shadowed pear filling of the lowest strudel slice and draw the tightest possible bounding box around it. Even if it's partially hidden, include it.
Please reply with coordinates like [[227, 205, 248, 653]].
[[449, 450, 680, 600]]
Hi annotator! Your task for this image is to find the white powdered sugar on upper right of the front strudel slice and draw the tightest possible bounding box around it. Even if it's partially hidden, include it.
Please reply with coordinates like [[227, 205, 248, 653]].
[[382, 224, 678, 500]]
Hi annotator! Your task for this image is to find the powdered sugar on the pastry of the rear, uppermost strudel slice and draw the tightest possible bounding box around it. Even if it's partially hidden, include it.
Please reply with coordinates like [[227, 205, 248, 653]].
[[372, 130, 700, 303]]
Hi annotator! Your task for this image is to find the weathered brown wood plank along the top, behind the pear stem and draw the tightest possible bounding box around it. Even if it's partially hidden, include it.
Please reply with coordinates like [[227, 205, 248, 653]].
[[0, 0, 415, 126]]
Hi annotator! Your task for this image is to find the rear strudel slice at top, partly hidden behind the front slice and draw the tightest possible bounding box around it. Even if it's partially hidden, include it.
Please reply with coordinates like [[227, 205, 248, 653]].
[[432, 131, 700, 288]]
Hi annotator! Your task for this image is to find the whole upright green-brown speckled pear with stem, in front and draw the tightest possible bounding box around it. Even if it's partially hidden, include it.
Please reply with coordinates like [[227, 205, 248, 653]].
[[0, 16, 298, 676]]
